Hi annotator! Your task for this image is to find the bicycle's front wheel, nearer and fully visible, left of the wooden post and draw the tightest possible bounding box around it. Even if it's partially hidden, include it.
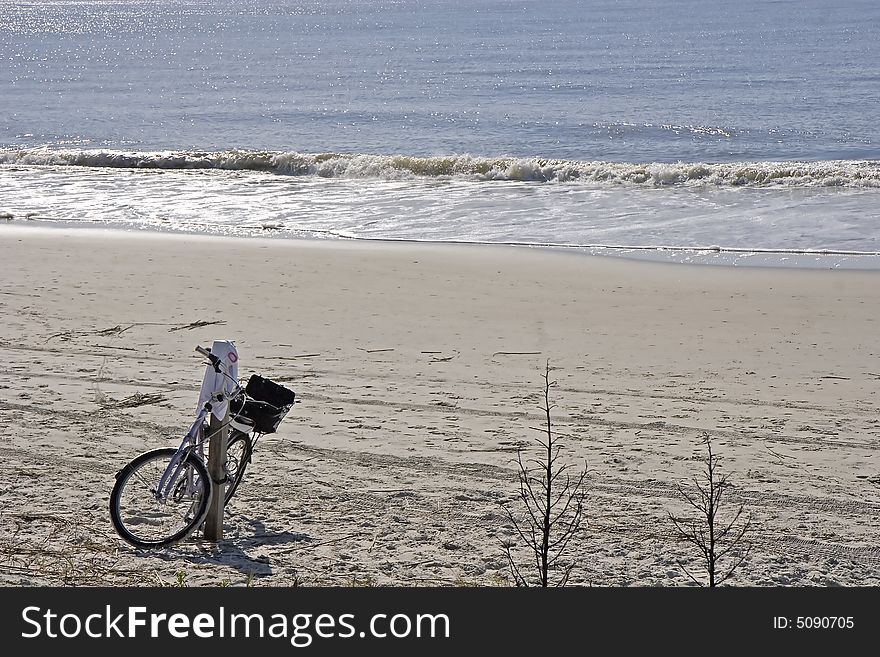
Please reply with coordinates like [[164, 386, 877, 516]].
[[110, 447, 211, 548]]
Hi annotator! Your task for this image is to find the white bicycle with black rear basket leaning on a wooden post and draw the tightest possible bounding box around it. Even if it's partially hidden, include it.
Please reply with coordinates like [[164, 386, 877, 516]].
[[110, 342, 296, 548]]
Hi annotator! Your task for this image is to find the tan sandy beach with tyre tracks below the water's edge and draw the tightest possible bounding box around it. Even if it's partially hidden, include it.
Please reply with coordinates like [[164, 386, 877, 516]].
[[0, 225, 880, 586]]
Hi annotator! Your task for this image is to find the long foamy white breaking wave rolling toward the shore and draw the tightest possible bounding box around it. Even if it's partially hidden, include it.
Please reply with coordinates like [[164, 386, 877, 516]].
[[0, 148, 880, 188]]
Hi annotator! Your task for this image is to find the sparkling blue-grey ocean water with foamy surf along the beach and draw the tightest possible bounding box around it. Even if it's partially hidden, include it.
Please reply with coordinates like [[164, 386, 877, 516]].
[[0, 0, 880, 268]]
